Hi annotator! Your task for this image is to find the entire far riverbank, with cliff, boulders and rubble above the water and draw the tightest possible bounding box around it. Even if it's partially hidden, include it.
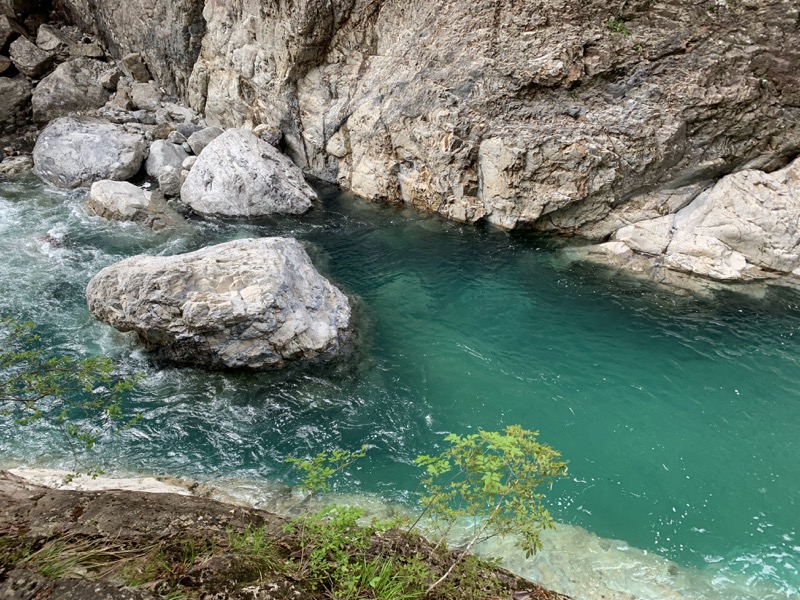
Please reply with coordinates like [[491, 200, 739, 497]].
[[0, 0, 800, 288]]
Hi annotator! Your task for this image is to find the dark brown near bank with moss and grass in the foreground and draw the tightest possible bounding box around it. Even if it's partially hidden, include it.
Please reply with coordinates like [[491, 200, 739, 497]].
[[0, 472, 567, 600]]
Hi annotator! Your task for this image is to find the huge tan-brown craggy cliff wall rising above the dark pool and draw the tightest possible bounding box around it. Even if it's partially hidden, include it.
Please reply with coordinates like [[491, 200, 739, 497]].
[[181, 0, 800, 238]]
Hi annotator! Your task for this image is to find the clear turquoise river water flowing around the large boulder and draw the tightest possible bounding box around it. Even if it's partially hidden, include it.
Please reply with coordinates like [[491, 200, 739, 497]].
[[0, 179, 800, 598]]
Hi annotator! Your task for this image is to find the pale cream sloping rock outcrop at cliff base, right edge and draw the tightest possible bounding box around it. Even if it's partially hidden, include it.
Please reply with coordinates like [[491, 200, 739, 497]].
[[572, 159, 800, 281]]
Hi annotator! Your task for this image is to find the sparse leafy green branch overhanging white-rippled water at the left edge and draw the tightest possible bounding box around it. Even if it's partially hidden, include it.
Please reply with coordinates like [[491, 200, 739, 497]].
[[0, 318, 138, 472]]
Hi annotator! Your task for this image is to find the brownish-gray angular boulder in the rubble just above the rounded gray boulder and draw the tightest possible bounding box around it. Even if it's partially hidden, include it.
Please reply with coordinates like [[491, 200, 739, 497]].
[[33, 58, 109, 123]]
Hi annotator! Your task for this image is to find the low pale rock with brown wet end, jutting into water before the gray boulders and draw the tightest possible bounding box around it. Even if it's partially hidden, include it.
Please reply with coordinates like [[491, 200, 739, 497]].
[[86, 181, 183, 231]]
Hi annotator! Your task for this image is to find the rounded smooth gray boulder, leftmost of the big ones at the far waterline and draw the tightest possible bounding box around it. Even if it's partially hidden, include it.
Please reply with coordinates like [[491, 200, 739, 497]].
[[33, 117, 145, 188]]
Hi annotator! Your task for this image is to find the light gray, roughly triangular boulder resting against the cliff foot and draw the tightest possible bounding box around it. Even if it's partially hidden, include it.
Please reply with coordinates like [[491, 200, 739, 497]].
[[181, 129, 317, 217]]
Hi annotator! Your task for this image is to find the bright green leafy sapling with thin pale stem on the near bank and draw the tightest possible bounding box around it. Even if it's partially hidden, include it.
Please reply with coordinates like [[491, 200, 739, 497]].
[[415, 425, 567, 592]]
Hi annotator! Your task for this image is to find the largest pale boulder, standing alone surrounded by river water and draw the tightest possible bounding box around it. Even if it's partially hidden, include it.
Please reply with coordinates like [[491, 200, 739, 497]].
[[86, 238, 350, 369]]
